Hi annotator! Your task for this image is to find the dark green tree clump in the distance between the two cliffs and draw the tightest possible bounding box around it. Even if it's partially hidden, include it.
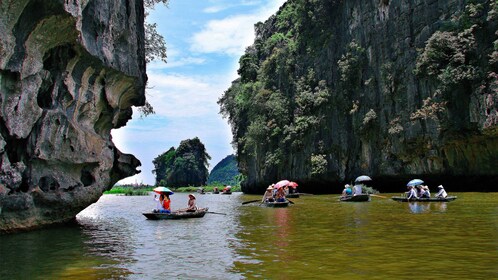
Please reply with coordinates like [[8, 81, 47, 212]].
[[152, 137, 211, 187]]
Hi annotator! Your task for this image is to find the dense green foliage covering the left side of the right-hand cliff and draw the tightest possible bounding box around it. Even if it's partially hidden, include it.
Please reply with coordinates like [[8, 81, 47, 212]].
[[218, 0, 336, 180]]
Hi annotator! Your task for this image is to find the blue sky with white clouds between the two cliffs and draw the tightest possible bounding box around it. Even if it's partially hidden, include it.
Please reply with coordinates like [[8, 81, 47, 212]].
[[112, 0, 285, 185]]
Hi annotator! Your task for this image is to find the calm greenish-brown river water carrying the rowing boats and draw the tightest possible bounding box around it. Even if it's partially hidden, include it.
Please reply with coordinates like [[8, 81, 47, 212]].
[[0, 193, 498, 279]]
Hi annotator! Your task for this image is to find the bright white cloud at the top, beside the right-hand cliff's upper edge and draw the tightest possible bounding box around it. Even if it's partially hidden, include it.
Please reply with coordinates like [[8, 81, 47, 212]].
[[191, 0, 285, 56]]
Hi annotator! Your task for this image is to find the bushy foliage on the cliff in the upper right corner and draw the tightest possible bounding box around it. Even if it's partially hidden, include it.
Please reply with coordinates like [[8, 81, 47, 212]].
[[411, 0, 498, 129]]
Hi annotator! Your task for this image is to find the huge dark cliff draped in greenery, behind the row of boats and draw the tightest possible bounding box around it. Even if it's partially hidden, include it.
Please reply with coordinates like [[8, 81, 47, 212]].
[[219, 0, 498, 193]]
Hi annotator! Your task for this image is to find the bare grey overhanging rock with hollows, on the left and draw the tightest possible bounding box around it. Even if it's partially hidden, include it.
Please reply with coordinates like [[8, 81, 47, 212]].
[[0, 0, 146, 231]]
